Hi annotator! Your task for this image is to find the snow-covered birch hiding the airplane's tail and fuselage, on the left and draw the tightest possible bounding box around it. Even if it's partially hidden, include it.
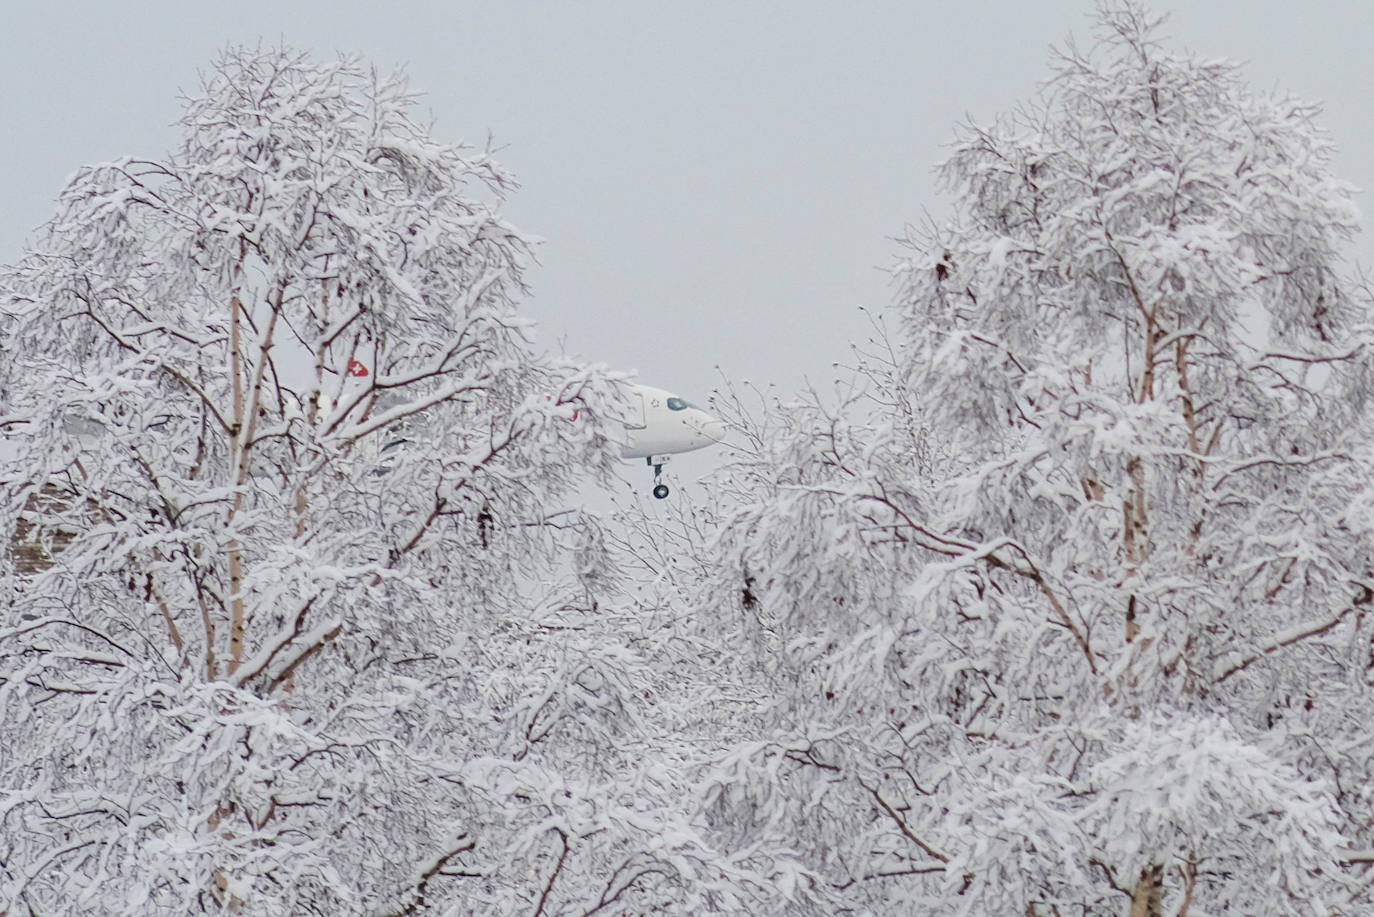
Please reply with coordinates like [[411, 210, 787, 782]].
[[0, 49, 743, 916]]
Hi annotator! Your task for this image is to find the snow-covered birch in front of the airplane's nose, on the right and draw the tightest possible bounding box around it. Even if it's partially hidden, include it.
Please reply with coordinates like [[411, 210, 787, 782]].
[[701, 3, 1374, 917]]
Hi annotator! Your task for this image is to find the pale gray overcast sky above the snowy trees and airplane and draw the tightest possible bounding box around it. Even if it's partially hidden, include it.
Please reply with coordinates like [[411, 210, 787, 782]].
[[0, 0, 1374, 409]]
